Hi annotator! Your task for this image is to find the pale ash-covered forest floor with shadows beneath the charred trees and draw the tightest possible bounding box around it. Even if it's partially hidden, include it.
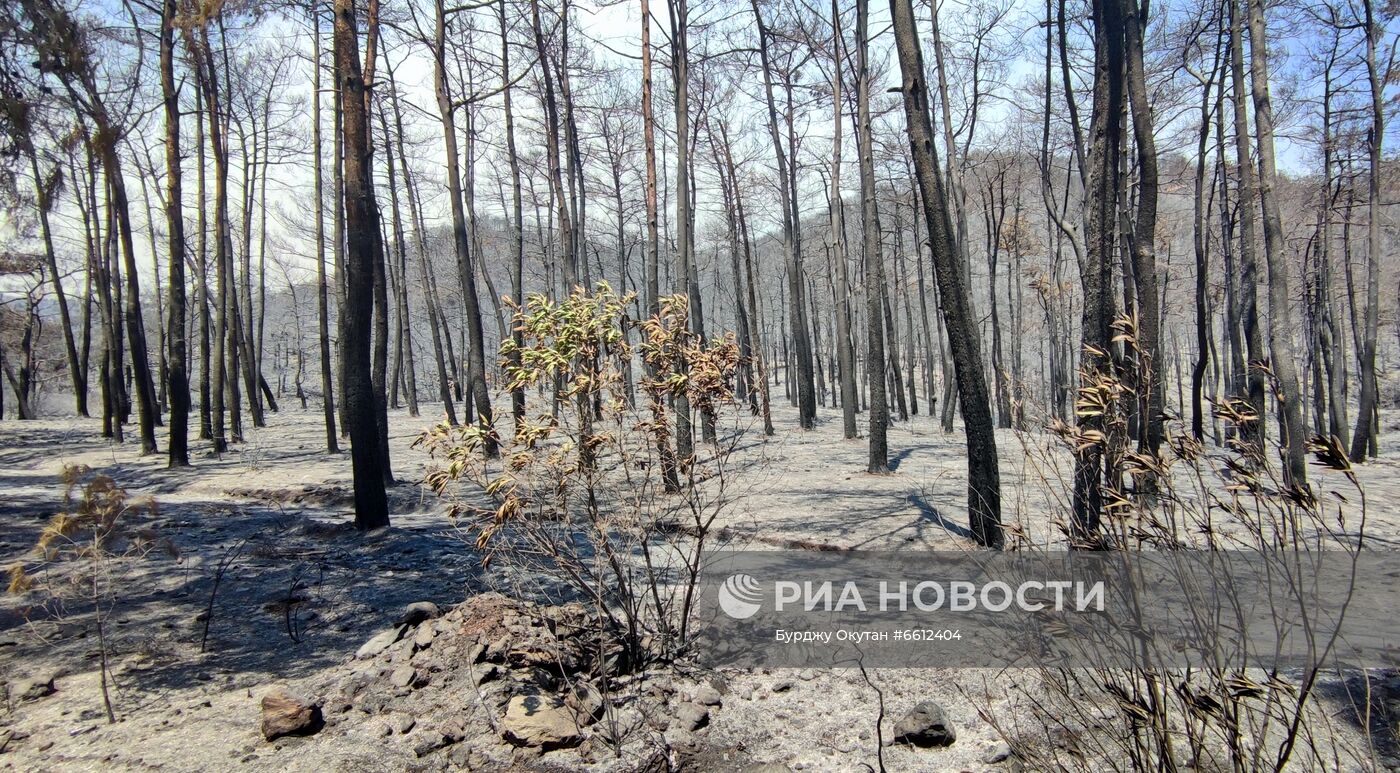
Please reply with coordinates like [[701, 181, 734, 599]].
[[0, 405, 1400, 772]]
